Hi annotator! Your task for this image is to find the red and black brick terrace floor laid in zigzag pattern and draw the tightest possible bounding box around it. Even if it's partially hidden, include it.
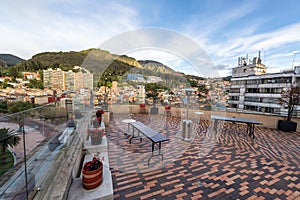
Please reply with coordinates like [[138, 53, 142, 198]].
[[107, 114, 300, 199]]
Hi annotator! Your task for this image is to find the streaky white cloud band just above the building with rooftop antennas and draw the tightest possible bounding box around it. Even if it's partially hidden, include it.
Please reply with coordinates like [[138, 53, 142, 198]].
[[196, 20, 300, 72]]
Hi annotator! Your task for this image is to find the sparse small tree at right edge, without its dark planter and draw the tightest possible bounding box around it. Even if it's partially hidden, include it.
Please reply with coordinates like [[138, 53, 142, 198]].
[[280, 86, 300, 121]]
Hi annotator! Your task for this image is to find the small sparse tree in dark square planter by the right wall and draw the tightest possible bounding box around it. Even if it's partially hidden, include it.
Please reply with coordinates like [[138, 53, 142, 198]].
[[277, 86, 300, 132]]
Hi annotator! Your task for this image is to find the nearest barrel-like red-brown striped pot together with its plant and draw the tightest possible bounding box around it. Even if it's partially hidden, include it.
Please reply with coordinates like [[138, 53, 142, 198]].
[[82, 157, 103, 190]]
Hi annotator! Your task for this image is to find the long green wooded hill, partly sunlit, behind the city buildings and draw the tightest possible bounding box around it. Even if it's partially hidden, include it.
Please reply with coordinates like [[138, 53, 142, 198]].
[[17, 49, 189, 88]]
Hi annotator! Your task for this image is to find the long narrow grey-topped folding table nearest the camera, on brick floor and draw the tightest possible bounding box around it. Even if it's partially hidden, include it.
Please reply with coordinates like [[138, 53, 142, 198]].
[[128, 121, 169, 165]]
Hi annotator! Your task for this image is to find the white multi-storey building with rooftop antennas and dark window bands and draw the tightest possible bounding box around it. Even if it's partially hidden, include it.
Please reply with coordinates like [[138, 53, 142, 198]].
[[227, 54, 300, 116]]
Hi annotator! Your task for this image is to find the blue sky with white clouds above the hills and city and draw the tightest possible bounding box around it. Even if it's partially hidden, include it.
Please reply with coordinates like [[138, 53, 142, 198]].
[[0, 0, 300, 76]]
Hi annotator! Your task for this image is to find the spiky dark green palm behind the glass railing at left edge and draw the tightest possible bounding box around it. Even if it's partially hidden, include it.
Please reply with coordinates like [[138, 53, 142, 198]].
[[0, 128, 21, 163]]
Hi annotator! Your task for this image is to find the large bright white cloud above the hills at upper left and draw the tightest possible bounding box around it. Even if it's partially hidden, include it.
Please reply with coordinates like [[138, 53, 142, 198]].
[[0, 1, 139, 58]]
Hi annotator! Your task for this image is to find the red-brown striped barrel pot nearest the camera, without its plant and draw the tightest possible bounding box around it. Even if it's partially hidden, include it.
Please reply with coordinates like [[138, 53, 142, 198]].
[[82, 161, 103, 190]]
